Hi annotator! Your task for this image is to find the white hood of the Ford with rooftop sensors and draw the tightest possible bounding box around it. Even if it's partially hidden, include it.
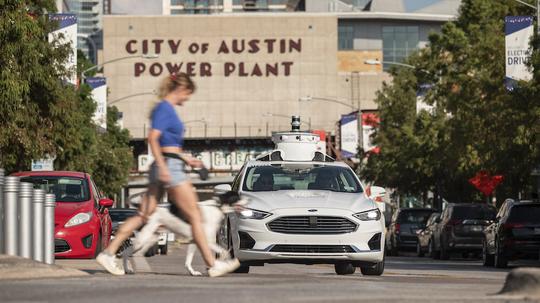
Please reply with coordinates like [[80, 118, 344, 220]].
[[242, 190, 377, 213]]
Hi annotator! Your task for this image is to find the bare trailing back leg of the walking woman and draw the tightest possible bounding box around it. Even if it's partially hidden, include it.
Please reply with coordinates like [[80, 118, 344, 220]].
[[105, 185, 160, 255]]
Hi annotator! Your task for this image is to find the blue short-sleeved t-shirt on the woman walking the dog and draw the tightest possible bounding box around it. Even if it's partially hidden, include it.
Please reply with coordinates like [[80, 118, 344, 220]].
[[152, 100, 184, 147]]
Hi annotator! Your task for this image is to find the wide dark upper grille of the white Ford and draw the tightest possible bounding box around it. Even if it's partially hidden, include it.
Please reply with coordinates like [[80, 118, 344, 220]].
[[267, 216, 357, 235]]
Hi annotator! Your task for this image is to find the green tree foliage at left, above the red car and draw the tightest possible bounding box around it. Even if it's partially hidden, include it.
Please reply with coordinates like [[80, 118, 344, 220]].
[[0, 0, 132, 196]]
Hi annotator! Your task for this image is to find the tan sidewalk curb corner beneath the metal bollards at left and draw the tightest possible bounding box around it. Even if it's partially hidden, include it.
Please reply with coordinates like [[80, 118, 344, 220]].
[[0, 255, 89, 281]]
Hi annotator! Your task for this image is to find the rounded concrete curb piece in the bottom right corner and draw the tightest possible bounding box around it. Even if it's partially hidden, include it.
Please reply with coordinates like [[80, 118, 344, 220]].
[[497, 268, 540, 298]]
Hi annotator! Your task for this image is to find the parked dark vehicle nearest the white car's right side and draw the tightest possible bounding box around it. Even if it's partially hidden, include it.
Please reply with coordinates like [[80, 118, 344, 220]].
[[386, 208, 435, 256]]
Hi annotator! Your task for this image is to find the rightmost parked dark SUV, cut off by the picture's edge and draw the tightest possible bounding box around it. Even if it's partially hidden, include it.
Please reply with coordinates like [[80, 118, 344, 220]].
[[482, 199, 540, 268]]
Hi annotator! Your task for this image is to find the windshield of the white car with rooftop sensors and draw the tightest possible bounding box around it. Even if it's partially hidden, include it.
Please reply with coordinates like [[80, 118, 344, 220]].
[[243, 164, 363, 193]]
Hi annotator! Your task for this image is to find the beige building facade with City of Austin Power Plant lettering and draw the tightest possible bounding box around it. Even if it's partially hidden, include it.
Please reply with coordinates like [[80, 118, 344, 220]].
[[102, 0, 459, 170]]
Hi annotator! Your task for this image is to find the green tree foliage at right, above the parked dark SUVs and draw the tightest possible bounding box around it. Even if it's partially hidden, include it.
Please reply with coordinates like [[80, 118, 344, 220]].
[[362, 0, 540, 202]]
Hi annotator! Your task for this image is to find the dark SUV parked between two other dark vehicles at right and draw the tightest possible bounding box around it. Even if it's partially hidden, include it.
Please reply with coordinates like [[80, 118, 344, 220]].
[[431, 203, 496, 260]]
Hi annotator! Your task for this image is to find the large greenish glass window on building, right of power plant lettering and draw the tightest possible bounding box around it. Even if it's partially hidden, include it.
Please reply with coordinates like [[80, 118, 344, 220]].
[[383, 26, 419, 68]]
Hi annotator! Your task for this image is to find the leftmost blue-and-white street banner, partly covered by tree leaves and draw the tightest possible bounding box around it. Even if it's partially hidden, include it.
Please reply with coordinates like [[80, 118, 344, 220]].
[[49, 14, 77, 85]]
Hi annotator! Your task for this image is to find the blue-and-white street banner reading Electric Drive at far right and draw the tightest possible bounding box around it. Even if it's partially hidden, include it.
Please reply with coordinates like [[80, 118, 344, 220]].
[[504, 16, 534, 91]]
